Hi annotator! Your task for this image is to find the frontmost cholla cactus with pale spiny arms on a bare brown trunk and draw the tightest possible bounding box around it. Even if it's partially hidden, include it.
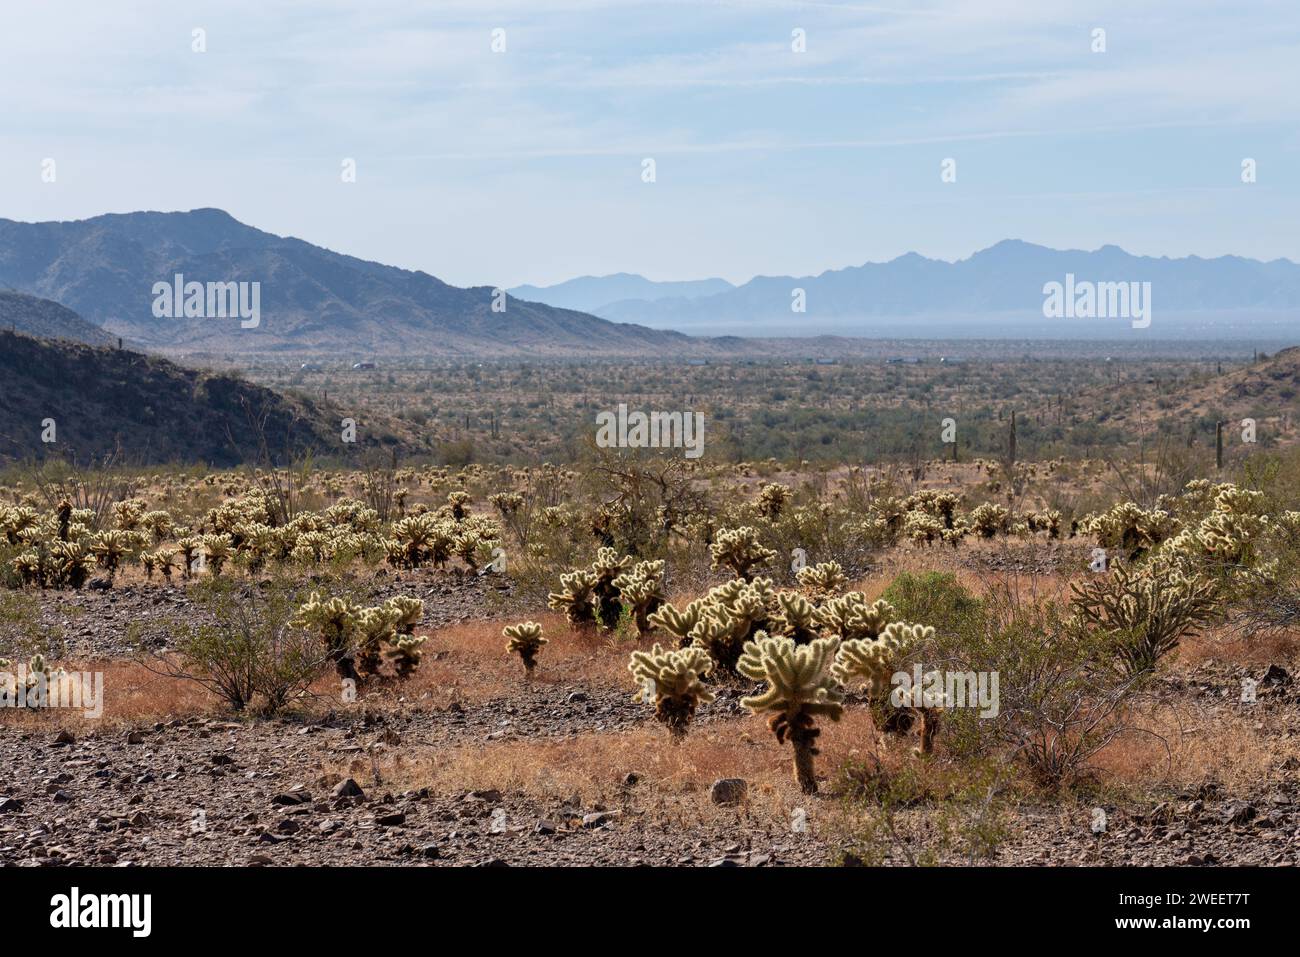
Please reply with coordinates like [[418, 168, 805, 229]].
[[737, 635, 844, 794]]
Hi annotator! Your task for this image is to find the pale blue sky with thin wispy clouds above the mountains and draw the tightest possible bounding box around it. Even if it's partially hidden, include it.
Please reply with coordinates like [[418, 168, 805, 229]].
[[0, 0, 1300, 286]]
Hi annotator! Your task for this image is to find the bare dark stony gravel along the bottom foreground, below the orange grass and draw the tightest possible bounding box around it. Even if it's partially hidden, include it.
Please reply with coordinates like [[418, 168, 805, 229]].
[[0, 670, 1300, 866]]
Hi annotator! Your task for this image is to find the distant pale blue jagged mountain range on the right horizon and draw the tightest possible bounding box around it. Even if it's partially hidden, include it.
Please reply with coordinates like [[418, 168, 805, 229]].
[[601, 239, 1300, 337]]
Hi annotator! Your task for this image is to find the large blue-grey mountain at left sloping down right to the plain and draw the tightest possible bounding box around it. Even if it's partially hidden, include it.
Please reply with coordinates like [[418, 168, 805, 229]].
[[0, 209, 690, 355]]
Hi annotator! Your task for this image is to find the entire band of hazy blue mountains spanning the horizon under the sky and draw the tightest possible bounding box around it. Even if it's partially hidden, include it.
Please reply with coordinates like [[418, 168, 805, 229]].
[[0, 209, 1300, 358]]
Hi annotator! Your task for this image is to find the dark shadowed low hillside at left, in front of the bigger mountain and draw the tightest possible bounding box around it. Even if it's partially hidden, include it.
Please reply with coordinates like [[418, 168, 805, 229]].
[[0, 330, 429, 467]]
